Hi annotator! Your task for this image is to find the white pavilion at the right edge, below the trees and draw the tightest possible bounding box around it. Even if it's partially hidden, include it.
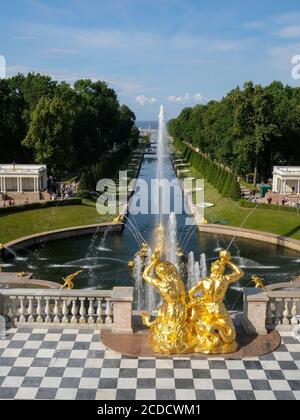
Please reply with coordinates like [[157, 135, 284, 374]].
[[273, 166, 300, 195]]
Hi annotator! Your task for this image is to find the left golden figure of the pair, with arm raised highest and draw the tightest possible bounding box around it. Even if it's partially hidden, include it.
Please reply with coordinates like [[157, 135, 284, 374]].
[[141, 246, 193, 354]]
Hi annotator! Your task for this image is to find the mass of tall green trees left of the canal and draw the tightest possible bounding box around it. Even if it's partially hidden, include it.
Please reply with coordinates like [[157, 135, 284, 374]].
[[0, 73, 139, 176]]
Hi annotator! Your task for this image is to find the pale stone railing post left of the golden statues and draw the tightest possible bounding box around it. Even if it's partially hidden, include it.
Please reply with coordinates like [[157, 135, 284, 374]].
[[111, 287, 133, 334]]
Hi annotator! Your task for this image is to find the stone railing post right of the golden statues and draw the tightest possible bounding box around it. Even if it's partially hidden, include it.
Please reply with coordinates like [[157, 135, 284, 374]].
[[242, 287, 269, 335]]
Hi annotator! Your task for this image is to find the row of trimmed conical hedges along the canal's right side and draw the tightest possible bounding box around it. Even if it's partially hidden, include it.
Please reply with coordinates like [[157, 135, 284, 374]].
[[173, 139, 241, 200]]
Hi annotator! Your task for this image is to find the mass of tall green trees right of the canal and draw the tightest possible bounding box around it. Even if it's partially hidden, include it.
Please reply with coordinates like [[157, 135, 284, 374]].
[[168, 81, 300, 184]]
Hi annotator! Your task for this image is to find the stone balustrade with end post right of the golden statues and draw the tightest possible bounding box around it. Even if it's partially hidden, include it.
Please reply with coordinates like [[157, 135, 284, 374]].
[[243, 280, 300, 334]]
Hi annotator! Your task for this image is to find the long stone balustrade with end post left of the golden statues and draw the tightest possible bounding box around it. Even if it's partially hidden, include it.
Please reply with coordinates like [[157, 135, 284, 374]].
[[0, 287, 133, 333]]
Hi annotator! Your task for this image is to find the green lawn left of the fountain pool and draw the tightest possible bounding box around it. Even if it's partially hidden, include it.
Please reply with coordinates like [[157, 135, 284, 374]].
[[0, 200, 115, 243]]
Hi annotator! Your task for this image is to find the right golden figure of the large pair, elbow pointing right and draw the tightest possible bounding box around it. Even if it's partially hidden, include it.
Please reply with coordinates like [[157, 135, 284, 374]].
[[188, 251, 244, 354]]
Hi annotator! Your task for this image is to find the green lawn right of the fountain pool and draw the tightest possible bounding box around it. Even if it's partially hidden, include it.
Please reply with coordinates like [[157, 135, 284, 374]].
[[188, 168, 300, 240]]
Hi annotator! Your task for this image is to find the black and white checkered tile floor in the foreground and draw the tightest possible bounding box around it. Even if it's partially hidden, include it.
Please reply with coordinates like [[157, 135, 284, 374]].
[[0, 328, 300, 400]]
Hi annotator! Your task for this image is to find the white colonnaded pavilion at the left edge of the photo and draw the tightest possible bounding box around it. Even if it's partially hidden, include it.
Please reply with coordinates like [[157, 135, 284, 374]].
[[0, 163, 47, 199]]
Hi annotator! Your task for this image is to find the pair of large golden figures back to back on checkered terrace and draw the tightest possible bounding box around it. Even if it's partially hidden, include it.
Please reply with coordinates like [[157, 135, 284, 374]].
[[141, 242, 244, 354]]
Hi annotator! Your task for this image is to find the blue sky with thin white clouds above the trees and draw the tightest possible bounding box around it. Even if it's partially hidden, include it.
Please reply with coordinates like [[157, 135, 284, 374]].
[[0, 0, 300, 120]]
